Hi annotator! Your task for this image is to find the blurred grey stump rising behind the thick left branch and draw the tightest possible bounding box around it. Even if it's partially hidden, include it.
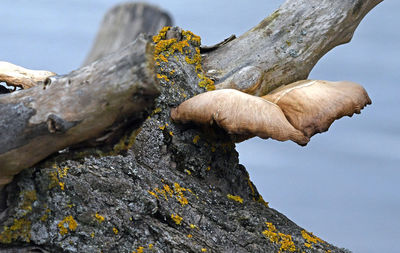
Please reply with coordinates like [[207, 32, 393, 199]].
[[83, 3, 172, 65]]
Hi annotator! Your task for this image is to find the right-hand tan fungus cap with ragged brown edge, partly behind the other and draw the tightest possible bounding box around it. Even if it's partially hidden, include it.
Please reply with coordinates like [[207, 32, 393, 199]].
[[263, 80, 371, 137]]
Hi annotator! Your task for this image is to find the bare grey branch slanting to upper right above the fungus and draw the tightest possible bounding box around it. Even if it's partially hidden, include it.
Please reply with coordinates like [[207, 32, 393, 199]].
[[204, 0, 382, 96]]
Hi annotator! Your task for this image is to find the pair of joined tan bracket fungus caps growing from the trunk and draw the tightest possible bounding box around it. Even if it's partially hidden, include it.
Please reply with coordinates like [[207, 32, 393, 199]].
[[171, 80, 371, 146]]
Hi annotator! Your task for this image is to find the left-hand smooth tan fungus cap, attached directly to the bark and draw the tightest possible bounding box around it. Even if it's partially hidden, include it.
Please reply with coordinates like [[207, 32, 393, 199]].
[[171, 89, 309, 145]]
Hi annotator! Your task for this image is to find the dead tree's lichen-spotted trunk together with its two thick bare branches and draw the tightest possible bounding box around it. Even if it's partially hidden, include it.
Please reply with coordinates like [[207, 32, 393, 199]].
[[0, 0, 380, 252]]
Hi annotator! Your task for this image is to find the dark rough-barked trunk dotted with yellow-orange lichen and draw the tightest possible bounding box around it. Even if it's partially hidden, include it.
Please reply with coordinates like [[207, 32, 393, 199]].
[[0, 1, 382, 252]]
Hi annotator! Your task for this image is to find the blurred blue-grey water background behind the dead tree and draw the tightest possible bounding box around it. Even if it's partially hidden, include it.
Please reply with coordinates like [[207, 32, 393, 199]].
[[0, 0, 400, 253]]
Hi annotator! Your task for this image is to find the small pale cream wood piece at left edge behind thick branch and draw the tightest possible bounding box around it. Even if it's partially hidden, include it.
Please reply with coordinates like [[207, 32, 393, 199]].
[[0, 61, 56, 89]]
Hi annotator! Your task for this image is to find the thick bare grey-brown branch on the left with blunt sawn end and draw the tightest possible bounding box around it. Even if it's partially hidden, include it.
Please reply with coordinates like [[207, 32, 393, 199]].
[[0, 37, 158, 186]]
